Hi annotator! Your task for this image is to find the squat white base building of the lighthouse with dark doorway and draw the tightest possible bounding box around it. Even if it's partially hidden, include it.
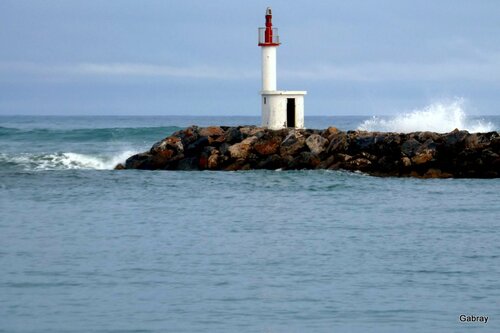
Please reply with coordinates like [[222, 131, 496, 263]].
[[260, 90, 307, 129]]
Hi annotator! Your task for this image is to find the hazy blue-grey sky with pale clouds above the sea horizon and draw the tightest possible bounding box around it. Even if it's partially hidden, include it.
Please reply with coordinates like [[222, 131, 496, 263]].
[[0, 0, 500, 116]]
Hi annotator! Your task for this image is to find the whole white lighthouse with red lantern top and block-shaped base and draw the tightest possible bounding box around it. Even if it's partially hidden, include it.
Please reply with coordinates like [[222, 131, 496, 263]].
[[259, 7, 307, 129]]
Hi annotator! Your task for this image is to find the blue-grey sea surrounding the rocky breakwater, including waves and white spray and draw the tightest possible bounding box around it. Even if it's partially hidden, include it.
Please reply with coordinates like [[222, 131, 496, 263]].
[[0, 105, 500, 333]]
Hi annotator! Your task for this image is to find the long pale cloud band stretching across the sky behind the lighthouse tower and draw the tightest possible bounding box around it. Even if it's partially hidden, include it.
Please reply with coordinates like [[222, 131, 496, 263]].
[[0, 54, 500, 82]]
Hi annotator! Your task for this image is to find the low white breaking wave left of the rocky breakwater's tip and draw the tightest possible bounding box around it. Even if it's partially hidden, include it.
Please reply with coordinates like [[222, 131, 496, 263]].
[[0, 151, 136, 170]]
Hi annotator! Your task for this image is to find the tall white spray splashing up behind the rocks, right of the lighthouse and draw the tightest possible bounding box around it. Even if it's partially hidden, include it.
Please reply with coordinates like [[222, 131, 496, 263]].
[[357, 98, 495, 133]]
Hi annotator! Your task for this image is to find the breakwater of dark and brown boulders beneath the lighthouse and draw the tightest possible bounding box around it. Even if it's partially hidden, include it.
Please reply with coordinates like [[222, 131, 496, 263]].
[[116, 126, 500, 178]]
